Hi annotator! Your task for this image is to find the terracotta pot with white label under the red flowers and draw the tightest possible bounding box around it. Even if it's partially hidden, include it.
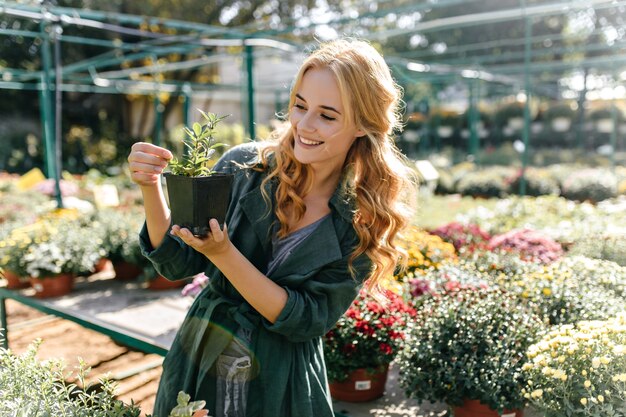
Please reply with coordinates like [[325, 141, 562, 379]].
[[330, 365, 389, 402]]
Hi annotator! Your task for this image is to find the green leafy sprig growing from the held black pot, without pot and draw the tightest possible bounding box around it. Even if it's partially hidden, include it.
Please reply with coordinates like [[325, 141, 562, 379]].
[[169, 110, 226, 177]]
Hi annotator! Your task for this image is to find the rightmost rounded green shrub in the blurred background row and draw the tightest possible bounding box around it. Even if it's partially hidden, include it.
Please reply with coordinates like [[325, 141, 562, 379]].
[[561, 168, 617, 202]]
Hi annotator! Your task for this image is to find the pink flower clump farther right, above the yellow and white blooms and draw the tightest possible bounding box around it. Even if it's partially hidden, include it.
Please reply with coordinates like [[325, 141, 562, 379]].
[[488, 229, 563, 264]]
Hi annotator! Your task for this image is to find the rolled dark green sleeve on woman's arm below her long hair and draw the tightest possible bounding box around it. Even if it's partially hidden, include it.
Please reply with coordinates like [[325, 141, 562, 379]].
[[264, 255, 371, 342]]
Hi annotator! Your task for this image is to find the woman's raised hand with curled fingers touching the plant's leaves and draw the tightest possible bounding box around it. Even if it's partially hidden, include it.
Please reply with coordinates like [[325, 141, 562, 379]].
[[128, 142, 172, 187]]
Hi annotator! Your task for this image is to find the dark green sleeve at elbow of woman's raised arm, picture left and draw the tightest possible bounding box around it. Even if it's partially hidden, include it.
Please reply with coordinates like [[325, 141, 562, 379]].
[[139, 223, 209, 280]]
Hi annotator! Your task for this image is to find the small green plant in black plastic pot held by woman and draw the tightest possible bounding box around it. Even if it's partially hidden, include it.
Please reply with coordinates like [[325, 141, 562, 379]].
[[165, 111, 233, 236]]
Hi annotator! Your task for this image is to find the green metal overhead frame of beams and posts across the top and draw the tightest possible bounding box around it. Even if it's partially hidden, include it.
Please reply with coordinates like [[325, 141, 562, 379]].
[[0, 0, 626, 199]]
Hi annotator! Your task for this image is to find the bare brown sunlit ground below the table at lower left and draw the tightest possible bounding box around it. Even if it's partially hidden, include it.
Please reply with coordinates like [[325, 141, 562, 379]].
[[6, 300, 163, 415]]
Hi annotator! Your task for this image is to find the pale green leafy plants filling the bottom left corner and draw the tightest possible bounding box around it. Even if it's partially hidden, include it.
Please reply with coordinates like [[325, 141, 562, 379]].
[[0, 341, 140, 417]]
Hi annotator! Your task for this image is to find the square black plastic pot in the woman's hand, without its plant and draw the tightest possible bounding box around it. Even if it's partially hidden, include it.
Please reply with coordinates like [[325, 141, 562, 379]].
[[165, 172, 233, 237]]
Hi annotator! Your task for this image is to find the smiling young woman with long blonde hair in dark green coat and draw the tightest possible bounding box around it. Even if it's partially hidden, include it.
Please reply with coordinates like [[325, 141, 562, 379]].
[[128, 40, 414, 417]]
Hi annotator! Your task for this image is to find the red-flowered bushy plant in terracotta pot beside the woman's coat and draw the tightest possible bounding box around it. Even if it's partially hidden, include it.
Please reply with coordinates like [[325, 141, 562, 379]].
[[324, 291, 415, 402]]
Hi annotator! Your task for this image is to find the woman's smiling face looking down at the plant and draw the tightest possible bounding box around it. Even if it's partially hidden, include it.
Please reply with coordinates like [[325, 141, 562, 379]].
[[289, 67, 364, 172]]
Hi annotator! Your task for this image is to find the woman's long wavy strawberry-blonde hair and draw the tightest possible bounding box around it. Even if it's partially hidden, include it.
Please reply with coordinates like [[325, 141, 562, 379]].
[[254, 39, 416, 293]]
